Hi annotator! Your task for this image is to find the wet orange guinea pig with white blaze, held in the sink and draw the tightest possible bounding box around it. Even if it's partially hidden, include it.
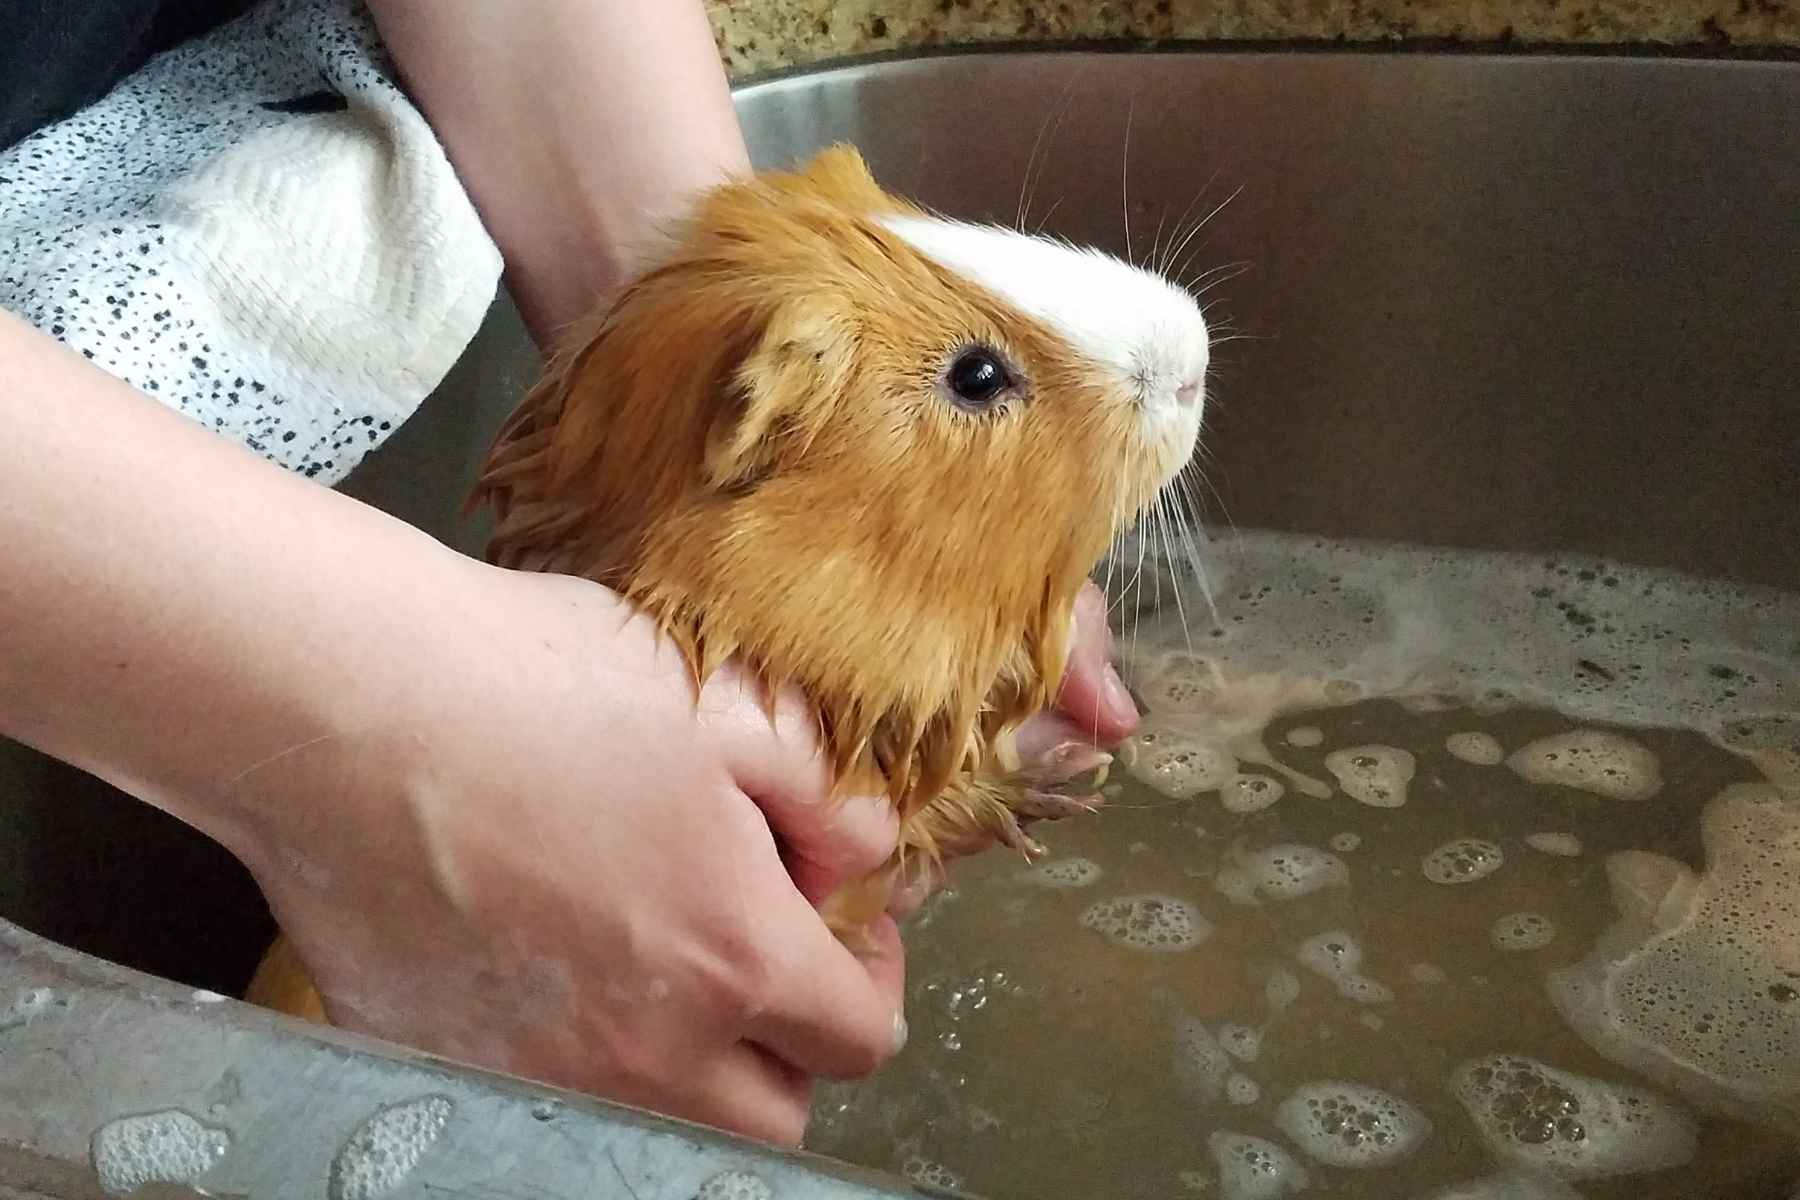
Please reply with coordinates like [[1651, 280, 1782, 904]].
[[252, 146, 1210, 1018]]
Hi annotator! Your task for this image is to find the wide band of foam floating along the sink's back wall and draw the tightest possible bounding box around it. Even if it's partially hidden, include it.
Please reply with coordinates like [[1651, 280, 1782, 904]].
[[1120, 531, 1800, 766]]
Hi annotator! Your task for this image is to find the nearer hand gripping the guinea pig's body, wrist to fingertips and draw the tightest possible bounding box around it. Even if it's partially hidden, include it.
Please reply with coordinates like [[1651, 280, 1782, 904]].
[[234, 560, 904, 1144]]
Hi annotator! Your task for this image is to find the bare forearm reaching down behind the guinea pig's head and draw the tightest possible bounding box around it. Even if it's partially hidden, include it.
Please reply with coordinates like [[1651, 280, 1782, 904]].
[[369, 0, 749, 344]]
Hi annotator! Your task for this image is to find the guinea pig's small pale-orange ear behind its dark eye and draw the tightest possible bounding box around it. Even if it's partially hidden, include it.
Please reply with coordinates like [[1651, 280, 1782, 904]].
[[706, 300, 853, 491]]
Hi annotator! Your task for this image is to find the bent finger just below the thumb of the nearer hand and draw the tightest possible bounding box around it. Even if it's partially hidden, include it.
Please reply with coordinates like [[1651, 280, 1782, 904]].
[[743, 896, 905, 1079]]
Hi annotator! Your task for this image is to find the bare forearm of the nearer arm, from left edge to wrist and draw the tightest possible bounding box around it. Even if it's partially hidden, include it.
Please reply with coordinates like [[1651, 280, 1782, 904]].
[[0, 313, 471, 847]]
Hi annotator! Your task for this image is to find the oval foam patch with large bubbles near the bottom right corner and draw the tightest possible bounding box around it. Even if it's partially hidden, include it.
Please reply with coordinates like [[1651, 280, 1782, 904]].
[[1451, 1054, 1699, 1178]]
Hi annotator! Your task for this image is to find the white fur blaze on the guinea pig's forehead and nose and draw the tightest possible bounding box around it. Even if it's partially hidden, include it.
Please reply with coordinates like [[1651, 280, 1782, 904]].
[[882, 216, 1210, 421]]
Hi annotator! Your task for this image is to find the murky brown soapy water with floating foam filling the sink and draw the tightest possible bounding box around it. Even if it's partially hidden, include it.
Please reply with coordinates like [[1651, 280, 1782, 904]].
[[808, 536, 1800, 1200]]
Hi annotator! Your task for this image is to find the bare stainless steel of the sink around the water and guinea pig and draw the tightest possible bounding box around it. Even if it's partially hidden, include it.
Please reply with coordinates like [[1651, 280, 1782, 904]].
[[0, 50, 1800, 1200]]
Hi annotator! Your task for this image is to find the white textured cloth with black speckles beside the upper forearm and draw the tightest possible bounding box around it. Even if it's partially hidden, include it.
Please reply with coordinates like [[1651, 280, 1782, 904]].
[[0, 0, 500, 484]]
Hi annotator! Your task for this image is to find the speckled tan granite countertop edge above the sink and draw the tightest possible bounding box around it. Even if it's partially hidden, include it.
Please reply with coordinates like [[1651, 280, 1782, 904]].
[[706, 0, 1800, 77]]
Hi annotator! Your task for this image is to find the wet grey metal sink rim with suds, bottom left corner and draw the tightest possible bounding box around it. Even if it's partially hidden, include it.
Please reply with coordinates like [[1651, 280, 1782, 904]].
[[0, 927, 950, 1200]]
